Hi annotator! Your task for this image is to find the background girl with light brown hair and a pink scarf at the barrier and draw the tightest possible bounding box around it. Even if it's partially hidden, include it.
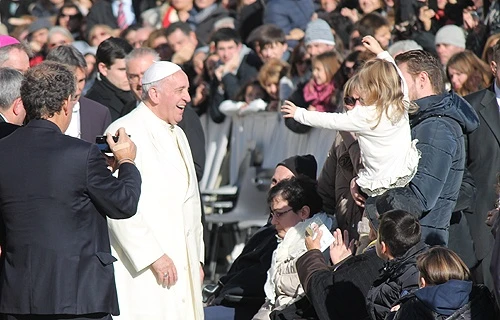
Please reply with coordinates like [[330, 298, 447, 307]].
[[302, 52, 340, 112]]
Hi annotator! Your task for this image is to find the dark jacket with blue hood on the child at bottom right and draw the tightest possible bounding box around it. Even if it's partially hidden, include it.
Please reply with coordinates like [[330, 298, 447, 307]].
[[393, 280, 496, 320]]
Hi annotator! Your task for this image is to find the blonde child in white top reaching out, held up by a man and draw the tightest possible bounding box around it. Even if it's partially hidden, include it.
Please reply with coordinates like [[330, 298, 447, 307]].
[[281, 36, 420, 196]]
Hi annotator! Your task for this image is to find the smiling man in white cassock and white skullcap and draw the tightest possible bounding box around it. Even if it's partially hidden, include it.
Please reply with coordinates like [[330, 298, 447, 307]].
[[107, 61, 204, 320]]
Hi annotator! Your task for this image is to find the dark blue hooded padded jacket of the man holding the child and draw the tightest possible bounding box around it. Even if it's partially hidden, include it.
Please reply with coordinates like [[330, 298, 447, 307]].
[[410, 92, 479, 245]]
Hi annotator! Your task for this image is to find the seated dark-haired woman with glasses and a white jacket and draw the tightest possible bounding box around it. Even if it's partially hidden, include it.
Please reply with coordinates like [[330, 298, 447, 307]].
[[253, 177, 333, 320]]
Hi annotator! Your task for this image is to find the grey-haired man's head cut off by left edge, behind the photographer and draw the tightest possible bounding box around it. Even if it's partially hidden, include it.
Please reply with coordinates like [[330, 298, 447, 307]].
[[0, 68, 26, 138]]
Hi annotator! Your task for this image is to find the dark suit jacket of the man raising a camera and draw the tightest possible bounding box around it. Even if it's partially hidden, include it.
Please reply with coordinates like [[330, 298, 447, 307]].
[[0, 120, 141, 315]]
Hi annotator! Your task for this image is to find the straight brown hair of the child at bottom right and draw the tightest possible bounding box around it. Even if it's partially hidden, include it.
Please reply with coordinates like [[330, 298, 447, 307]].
[[417, 247, 470, 285]]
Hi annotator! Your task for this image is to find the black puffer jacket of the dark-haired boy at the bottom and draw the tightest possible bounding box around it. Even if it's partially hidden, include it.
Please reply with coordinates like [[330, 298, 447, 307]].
[[366, 242, 427, 320]]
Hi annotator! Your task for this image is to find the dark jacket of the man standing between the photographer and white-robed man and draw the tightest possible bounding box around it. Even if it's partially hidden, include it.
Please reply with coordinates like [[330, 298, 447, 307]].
[[80, 97, 111, 143]]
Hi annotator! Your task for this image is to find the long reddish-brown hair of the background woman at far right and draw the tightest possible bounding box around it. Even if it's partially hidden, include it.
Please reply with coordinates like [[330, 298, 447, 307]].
[[446, 50, 491, 96]]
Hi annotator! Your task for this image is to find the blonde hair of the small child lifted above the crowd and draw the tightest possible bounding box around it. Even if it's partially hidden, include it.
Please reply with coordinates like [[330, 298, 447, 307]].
[[351, 59, 415, 128]]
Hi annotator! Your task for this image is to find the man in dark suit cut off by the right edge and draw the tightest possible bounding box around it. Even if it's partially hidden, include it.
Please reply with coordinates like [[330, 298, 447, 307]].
[[465, 45, 500, 288]]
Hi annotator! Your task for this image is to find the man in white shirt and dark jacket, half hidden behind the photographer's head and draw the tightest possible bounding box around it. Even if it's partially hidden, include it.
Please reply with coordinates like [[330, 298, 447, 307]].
[[46, 46, 111, 143]]
